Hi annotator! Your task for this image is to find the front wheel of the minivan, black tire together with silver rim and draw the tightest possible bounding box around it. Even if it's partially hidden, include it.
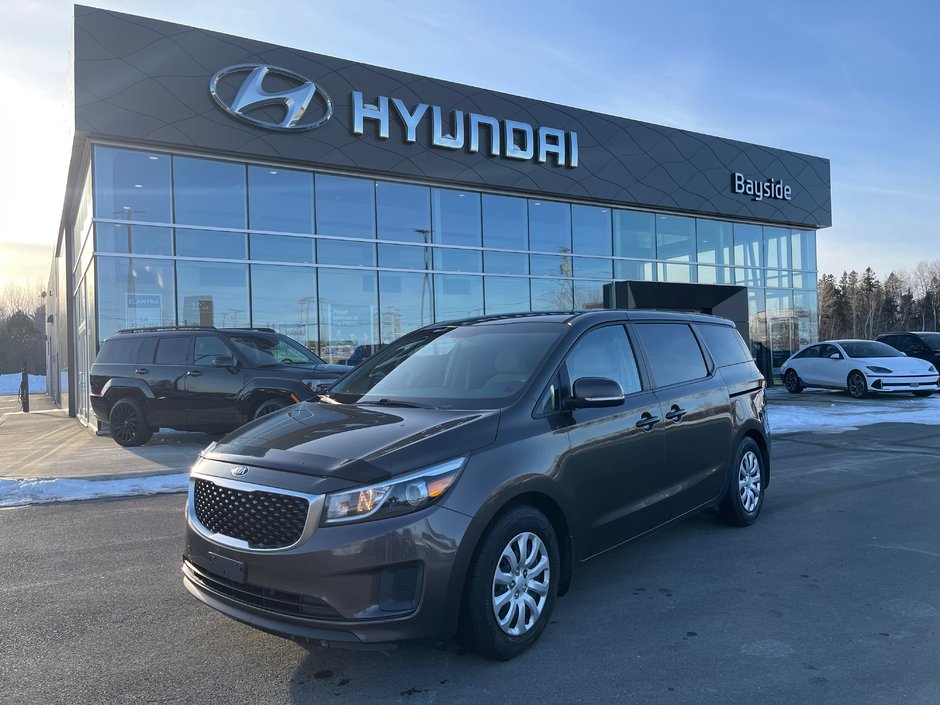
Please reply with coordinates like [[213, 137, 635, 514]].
[[458, 506, 561, 661]]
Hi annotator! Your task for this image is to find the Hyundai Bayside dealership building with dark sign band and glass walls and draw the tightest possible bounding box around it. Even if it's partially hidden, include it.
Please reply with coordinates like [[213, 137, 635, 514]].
[[45, 6, 831, 422]]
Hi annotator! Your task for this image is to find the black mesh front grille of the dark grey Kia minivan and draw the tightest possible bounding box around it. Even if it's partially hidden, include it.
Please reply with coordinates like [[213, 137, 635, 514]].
[[193, 478, 309, 549]]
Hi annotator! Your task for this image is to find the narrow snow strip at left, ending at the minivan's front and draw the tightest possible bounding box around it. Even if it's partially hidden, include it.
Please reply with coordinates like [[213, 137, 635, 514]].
[[0, 472, 189, 507]]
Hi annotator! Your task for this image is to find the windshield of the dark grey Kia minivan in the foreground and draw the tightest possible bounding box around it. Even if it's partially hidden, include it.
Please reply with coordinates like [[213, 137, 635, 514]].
[[329, 321, 567, 410]]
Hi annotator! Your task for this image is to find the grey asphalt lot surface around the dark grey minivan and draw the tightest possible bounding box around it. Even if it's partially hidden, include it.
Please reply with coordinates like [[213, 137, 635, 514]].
[[0, 400, 940, 705]]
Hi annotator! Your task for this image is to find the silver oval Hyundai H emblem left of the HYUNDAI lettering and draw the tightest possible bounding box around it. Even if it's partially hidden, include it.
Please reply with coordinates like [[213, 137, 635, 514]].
[[209, 64, 333, 130]]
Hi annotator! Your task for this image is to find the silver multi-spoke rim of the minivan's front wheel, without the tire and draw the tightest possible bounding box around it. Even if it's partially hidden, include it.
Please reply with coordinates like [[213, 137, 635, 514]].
[[492, 531, 551, 636]]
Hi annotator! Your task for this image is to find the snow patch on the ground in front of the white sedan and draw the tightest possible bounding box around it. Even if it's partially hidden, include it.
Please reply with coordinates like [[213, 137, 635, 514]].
[[767, 393, 940, 433]]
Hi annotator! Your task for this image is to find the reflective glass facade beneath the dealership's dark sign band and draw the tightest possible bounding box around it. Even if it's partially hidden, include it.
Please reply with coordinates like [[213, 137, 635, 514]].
[[88, 145, 818, 374]]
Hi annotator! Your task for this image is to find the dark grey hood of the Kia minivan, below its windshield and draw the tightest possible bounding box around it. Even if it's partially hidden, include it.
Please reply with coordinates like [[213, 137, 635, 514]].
[[203, 402, 499, 483]]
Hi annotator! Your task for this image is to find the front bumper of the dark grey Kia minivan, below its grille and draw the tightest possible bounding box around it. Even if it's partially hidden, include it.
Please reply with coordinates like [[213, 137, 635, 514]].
[[183, 470, 470, 646]]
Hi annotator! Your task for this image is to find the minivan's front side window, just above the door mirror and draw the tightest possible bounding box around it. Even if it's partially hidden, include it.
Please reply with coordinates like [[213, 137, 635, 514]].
[[565, 326, 642, 394]]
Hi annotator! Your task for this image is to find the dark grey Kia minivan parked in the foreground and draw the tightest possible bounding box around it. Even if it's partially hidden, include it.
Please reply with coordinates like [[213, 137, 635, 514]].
[[183, 311, 770, 659]]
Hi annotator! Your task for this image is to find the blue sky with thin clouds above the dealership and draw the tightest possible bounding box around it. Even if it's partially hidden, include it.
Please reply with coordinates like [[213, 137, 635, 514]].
[[0, 0, 940, 288]]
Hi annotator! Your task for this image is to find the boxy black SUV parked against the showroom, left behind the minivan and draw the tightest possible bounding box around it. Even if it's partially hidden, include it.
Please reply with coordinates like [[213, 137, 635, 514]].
[[89, 327, 353, 446]]
